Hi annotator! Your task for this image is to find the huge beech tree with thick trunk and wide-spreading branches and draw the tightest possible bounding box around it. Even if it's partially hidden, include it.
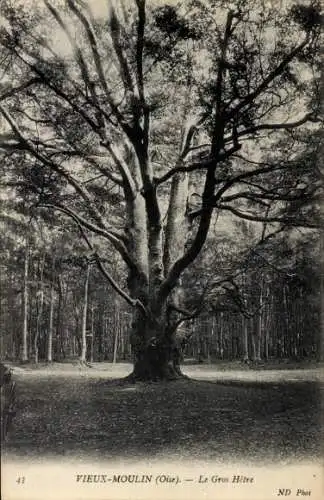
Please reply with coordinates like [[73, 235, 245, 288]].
[[0, 0, 321, 380]]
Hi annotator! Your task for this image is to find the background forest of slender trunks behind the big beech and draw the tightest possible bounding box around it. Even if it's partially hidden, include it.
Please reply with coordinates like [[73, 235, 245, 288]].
[[0, 207, 323, 362]]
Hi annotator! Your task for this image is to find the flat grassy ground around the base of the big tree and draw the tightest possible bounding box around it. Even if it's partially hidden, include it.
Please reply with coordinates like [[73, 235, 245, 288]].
[[3, 363, 323, 464]]
